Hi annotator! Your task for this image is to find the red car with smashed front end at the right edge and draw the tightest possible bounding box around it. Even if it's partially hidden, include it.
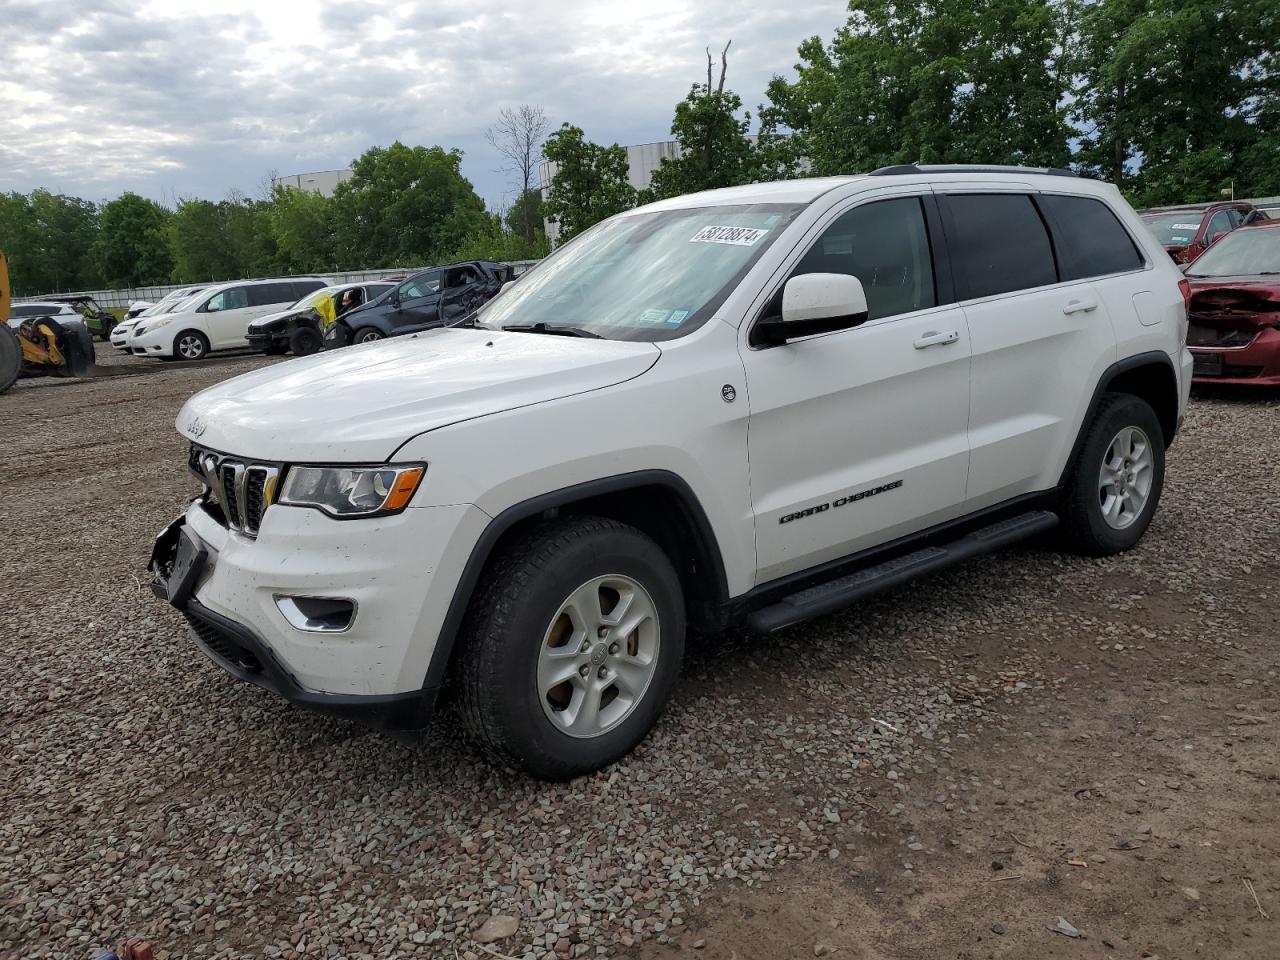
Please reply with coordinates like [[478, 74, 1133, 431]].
[[1184, 220, 1280, 387]]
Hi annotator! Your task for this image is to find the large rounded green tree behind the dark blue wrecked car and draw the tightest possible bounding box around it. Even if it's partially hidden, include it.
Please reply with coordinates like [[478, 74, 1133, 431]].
[[334, 141, 486, 268]]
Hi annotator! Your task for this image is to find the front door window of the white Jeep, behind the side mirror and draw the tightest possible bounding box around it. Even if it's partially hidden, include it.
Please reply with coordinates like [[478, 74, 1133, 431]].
[[791, 197, 938, 320]]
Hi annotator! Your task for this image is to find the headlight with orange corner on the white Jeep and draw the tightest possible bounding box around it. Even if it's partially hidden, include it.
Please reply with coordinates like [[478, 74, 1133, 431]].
[[279, 463, 426, 518]]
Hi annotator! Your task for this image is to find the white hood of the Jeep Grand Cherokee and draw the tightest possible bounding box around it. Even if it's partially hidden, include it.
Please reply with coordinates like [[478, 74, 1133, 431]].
[[177, 329, 662, 463]]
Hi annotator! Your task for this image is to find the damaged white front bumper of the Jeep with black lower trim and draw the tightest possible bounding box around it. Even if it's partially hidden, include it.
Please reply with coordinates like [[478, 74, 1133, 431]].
[[151, 500, 488, 730]]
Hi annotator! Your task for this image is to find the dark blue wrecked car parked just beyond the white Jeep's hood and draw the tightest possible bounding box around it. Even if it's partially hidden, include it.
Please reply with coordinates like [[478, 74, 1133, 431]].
[[325, 260, 515, 347]]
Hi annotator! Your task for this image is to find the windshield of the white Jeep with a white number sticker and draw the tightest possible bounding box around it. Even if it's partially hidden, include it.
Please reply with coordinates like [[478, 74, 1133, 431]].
[[477, 204, 801, 340]]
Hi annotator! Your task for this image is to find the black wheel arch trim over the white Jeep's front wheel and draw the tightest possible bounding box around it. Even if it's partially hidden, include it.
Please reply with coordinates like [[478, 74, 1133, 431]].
[[424, 470, 728, 687]]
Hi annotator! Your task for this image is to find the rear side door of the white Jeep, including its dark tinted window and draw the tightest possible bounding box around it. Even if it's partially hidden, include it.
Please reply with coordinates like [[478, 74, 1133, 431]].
[[937, 184, 1115, 511]]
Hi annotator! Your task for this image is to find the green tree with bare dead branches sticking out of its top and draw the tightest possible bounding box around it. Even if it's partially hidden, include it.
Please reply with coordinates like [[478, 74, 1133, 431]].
[[645, 41, 755, 200]]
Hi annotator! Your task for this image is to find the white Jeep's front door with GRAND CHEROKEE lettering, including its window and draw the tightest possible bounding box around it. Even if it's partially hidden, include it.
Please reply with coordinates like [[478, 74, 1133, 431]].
[[740, 187, 969, 582]]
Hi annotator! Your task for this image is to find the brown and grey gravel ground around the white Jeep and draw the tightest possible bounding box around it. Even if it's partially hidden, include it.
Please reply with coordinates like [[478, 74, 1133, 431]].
[[0, 347, 1280, 960]]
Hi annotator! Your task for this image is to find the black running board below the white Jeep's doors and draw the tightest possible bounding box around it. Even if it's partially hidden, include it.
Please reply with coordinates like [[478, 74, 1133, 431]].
[[746, 509, 1057, 634]]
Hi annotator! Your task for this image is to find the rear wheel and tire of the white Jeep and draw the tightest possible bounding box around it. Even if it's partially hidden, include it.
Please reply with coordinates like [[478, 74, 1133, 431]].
[[1061, 393, 1165, 557]]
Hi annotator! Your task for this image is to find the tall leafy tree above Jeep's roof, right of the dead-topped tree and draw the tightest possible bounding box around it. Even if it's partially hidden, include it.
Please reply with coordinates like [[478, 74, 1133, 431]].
[[760, 0, 1070, 174]]
